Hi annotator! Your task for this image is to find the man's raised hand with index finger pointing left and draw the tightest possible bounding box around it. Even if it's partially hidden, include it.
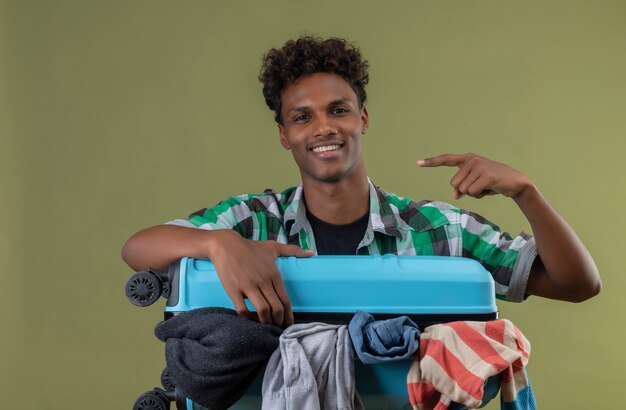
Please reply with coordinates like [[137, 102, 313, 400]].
[[417, 153, 532, 199]]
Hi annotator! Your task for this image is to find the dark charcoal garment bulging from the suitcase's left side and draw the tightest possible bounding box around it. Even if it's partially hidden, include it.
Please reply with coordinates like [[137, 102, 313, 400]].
[[155, 307, 282, 410]]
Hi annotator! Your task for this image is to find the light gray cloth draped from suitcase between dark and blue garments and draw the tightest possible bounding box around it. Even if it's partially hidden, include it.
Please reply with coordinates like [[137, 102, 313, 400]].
[[263, 323, 364, 410]]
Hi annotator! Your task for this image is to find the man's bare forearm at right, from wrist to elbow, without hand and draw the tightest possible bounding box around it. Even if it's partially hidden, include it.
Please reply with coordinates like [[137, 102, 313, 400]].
[[513, 183, 601, 302]]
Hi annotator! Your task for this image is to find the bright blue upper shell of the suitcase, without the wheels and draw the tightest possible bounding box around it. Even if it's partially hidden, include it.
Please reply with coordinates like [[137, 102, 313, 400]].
[[166, 255, 497, 322]]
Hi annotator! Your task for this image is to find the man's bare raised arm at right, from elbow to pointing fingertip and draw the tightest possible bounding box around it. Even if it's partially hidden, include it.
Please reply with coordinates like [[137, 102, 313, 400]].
[[417, 154, 602, 302]]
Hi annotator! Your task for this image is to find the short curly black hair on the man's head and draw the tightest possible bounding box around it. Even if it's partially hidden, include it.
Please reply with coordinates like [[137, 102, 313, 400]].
[[259, 36, 369, 124]]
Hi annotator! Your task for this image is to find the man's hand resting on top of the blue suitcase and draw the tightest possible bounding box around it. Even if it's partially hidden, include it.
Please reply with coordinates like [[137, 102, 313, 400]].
[[208, 230, 315, 326]]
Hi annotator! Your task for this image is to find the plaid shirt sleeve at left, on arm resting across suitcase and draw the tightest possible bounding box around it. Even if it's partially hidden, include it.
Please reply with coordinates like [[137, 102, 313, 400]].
[[165, 195, 253, 239]]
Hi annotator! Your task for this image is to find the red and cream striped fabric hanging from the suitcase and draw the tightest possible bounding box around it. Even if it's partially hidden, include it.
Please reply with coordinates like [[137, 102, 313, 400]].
[[407, 320, 537, 410]]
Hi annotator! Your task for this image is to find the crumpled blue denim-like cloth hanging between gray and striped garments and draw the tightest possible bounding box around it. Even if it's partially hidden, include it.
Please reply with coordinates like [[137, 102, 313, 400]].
[[348, 310, 420, 364]]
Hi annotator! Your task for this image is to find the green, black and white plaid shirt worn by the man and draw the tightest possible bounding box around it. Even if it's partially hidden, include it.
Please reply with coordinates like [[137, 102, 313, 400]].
[[168, 181, 537, 302]]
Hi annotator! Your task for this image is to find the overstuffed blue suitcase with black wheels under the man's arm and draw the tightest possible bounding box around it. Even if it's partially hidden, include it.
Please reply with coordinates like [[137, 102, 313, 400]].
[[126, 255, 498, 410]]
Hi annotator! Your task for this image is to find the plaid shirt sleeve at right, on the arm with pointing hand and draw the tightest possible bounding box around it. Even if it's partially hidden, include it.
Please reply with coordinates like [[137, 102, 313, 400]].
[[461, 210, 538, 302]]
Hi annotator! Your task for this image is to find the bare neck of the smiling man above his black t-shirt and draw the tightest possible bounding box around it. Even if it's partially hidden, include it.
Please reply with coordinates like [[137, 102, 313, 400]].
[[303, 176, 369, 225]]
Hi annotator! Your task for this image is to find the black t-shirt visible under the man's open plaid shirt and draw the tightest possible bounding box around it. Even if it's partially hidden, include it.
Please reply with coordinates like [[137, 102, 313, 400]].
[[306, 211, 370, 255]]
